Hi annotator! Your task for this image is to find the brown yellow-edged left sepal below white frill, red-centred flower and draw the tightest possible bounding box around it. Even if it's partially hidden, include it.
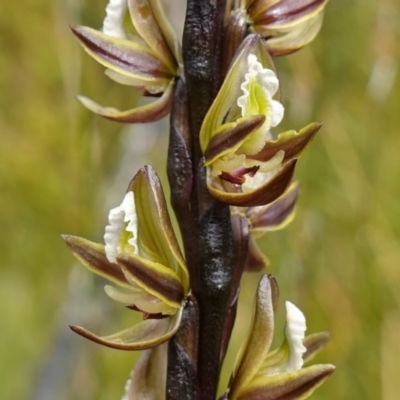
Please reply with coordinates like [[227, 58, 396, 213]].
[[204, 115, 265, 165]]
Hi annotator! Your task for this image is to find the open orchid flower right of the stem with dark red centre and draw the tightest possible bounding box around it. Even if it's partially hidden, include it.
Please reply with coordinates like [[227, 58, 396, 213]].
[[200, 35, 321, 207]]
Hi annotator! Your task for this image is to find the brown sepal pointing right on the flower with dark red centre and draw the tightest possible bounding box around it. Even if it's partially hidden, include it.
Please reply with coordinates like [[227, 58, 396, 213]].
[[249, 122, 322, 161]]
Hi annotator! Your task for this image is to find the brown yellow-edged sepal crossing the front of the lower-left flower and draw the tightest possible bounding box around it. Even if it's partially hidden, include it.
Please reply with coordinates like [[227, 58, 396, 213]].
[[117, 254, 184, 308]]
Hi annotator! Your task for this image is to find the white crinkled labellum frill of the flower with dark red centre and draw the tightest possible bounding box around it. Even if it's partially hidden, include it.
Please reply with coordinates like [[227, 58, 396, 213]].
[[237, 54, 284, 130]]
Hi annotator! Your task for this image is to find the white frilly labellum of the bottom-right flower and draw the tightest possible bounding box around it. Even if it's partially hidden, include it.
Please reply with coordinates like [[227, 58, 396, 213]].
[[285, 301, 307, 372]]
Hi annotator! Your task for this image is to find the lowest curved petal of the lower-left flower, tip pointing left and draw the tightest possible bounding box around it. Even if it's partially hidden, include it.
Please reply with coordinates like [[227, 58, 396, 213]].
[[70, 308, 183, 350]]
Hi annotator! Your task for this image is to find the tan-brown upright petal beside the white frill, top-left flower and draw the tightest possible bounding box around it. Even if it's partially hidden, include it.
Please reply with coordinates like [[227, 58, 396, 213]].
[[128, 0, 177, 74]]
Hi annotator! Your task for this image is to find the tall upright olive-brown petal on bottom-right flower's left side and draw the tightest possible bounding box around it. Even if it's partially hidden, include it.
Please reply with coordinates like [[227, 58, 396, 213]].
[[229, 275, 274, 399]]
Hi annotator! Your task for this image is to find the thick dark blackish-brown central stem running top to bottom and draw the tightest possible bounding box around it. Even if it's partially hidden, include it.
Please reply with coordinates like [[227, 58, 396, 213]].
[[179, 0, 238, 400]]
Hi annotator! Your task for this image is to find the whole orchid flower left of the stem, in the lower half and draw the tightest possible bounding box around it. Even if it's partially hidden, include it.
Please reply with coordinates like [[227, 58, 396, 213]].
[[64, 166, 189, 350]]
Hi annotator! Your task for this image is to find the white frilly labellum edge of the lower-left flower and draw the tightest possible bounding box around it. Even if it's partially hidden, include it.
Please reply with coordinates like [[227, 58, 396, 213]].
[[104, 192, 137, 263]]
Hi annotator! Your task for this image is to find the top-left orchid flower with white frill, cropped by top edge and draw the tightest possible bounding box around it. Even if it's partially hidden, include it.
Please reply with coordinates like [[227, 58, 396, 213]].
[[72, 0, 181, 122]]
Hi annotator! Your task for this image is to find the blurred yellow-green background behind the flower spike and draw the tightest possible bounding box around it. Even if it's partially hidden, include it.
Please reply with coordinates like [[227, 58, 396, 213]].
[[0, 0, 400, 400]]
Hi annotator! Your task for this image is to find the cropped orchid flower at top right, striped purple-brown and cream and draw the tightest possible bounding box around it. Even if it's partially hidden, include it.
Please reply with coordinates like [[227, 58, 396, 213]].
[[247, 0, 328, 56]]
